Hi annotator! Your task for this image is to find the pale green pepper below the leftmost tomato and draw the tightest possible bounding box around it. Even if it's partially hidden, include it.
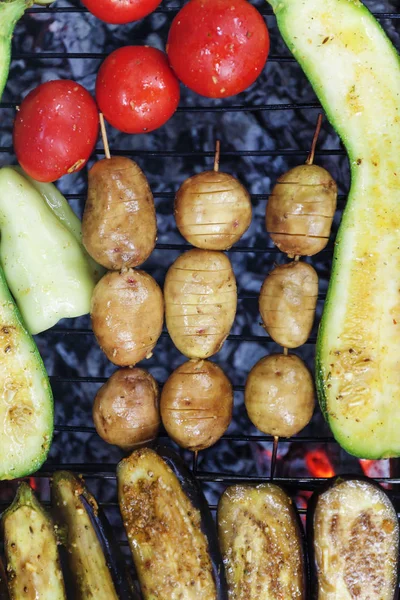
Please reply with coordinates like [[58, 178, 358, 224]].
[[0, 167, 98, 334]]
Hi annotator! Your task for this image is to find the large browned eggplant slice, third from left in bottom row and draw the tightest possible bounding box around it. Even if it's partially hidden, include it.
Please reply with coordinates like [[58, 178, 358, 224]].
[[118, 448, 226, 600]]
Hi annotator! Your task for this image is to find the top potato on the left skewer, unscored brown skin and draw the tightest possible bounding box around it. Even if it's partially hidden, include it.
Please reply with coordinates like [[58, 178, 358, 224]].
[[82, 156, 157, 271]]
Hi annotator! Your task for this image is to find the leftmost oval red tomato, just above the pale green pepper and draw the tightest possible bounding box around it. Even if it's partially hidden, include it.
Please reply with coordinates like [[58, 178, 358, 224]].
[[13, 80, 99, 182]]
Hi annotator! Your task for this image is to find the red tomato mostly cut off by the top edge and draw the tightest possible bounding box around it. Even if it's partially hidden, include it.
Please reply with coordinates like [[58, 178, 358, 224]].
[[82, 0, 161, 24]]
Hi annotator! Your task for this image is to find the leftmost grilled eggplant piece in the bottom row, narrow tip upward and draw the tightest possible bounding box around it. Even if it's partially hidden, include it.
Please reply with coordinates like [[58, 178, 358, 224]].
[[1, 483, 66, 600]]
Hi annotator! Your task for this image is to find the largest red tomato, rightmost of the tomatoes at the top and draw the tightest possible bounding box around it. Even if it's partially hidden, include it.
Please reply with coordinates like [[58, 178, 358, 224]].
[[167, 0, 269, 98]]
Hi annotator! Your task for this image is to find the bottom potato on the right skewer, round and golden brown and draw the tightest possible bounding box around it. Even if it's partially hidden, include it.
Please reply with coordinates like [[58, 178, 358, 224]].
[[245, 354, 314, 437]]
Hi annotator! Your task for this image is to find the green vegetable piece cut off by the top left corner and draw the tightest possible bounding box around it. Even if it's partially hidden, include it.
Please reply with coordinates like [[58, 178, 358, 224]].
[[0, 0, 33, 99]]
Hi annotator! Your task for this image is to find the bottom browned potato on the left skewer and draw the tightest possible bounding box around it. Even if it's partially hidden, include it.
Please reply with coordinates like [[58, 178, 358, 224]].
[[93, 369, 160, 450]]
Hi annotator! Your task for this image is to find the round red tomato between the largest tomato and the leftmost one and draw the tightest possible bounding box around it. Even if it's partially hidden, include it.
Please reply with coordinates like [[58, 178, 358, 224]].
[[96, 46, 180, 133]]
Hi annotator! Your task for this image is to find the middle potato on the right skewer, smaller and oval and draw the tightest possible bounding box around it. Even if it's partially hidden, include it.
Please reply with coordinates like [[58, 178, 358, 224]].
[[259, 262, 318, 348]]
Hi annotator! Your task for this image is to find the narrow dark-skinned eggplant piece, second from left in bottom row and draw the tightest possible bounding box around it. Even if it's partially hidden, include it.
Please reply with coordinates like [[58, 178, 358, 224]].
[[51, 471, 137, 600]]
